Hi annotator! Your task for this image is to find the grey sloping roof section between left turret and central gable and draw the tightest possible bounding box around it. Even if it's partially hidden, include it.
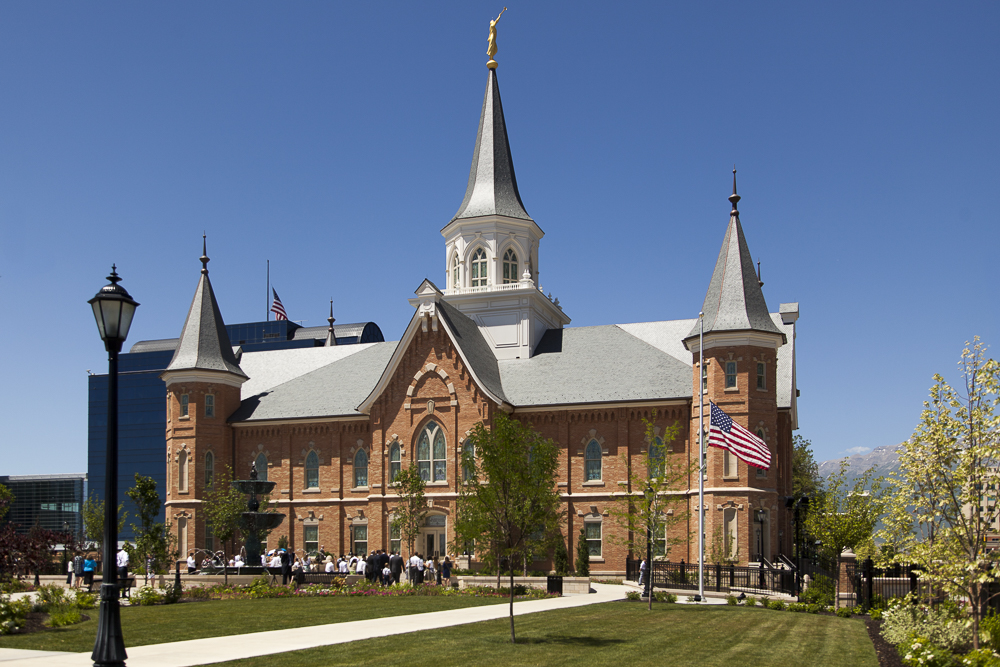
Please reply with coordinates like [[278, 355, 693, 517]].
[[229, 342, 396, 422]]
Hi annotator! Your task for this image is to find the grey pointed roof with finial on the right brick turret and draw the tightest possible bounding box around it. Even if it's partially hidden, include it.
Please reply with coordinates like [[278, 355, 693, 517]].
[[688, 168, 785, 340]]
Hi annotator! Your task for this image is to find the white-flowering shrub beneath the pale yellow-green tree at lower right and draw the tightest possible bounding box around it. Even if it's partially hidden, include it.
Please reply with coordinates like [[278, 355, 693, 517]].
[[882, 597, 972, 651]]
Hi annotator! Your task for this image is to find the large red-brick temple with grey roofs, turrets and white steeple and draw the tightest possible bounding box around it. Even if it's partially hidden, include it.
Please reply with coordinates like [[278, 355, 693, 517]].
[[162, 60, 798, 574]]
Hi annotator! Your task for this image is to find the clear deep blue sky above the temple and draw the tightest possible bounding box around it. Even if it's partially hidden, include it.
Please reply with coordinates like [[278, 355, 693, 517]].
[[0, 0, 1000, 474]]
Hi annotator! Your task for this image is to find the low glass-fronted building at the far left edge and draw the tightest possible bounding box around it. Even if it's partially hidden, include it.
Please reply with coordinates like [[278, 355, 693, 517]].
[[0, 473, 87, 536]]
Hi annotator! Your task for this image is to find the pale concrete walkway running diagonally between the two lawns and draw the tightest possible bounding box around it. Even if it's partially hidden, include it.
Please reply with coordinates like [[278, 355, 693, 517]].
[[0, 584, 628, 667]]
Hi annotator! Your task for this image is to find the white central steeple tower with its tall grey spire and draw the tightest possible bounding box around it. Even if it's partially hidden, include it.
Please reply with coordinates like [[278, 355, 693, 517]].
[[438, 49, 570, 359]]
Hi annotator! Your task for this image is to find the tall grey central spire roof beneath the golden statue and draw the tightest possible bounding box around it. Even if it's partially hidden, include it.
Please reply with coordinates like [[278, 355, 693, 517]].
[[452, 69, 531, 221]]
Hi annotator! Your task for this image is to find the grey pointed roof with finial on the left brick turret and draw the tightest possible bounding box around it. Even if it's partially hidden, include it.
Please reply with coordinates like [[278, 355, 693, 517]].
[[165, 237, 247, 379]]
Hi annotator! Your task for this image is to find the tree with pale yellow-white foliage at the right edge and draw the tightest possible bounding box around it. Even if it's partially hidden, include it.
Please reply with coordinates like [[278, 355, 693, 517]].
[[879, 337, 1000, 648]]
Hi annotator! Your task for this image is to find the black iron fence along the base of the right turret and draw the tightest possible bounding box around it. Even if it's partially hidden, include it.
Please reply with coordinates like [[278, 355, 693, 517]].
[[625, 560, 798, 595]]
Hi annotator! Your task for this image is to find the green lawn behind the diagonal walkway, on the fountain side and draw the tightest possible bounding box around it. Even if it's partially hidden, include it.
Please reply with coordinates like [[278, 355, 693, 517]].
[[0, 596, 507, 652]]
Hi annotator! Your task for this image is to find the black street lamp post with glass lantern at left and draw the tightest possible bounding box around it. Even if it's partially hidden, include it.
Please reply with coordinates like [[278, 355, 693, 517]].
[[88, 265, 139, 667]]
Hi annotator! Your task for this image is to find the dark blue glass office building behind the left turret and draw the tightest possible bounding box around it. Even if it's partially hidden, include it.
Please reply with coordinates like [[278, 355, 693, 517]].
[[87, 320, 383, 540]]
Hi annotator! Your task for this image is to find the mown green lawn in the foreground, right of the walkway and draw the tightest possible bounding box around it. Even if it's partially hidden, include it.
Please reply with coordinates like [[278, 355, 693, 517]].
[[207, 602, 878, 667]]
